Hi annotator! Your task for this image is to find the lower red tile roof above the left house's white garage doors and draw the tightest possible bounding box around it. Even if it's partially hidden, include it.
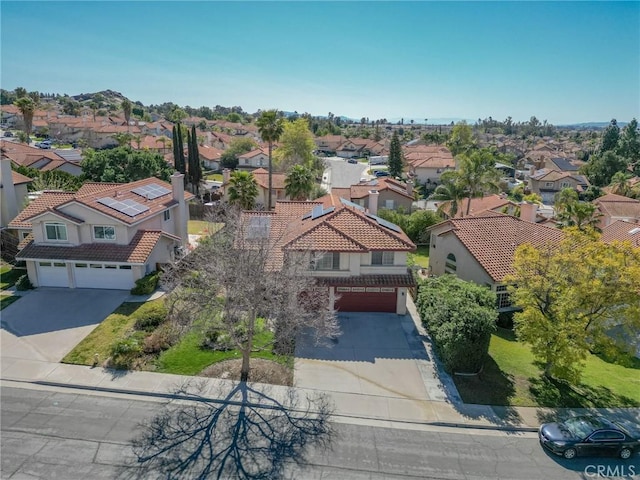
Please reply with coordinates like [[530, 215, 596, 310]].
[[16, 230, 180, 264]]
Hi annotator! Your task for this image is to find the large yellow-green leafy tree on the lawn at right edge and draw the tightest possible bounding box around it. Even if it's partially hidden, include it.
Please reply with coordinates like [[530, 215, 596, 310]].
[[505, 228, 640, 382]]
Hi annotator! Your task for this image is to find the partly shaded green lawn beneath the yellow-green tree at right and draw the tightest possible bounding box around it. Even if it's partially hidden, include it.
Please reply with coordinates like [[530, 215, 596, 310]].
[[454, 329, 640, 408]]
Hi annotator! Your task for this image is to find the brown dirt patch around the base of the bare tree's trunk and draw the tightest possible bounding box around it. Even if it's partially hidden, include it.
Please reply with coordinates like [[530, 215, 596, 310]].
[[198, 358, 293, 386]]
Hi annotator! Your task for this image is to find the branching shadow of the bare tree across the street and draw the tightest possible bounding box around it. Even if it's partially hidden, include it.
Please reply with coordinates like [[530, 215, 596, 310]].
[[118, 382, 333, 479]]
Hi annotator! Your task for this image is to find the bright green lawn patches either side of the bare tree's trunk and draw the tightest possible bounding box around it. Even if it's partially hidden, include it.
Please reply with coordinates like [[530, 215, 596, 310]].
[[156, 320, 290, 375]]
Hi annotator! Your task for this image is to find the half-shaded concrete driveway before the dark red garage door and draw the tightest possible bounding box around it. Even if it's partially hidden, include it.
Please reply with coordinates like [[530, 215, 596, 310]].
[[294, 313, 433, 400]]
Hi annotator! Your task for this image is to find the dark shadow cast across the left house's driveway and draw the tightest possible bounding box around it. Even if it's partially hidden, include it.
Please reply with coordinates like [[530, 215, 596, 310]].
[[0, 288, 129, 337]]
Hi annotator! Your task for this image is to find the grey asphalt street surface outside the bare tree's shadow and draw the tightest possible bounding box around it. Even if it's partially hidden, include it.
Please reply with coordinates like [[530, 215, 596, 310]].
[[1, 384, 640, 480]]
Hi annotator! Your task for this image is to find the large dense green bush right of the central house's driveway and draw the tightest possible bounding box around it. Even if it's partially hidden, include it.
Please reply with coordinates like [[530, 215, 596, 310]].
[[416, 275, 498, 373]]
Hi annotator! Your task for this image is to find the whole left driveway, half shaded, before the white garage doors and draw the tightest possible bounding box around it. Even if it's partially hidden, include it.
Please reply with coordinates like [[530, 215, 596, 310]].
[[0, 288, 129, 362]]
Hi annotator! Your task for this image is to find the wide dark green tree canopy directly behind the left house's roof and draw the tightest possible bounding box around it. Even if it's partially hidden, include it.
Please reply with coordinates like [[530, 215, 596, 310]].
[[81, 147, 173, 183]]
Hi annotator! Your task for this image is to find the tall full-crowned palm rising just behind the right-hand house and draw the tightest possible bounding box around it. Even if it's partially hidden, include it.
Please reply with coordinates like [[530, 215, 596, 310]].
[[458, 149, 500, 215]]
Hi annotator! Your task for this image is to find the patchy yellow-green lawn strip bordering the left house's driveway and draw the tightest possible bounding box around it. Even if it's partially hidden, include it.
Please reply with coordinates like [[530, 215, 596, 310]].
[[62, 298, 156, 365]]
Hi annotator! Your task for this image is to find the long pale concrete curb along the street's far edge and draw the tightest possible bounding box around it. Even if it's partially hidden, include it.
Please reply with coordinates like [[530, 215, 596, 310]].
[[0, 378, 538, 433]]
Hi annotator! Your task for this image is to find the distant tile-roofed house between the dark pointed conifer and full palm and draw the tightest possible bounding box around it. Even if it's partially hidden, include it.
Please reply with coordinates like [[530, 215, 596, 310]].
[[403, 145, 456, 184]]
